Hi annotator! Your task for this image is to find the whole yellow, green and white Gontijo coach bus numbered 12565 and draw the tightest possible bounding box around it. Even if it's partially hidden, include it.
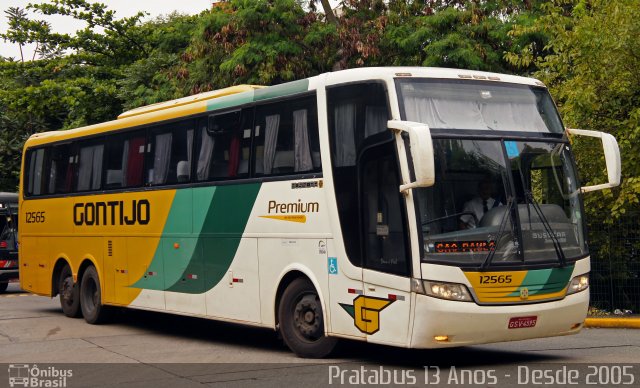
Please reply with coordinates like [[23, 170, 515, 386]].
[[19, 68, 620, 357]]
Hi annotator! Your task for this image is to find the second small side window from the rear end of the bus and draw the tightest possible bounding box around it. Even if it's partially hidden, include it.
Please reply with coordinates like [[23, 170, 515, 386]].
[[47, 143, 77, 194]]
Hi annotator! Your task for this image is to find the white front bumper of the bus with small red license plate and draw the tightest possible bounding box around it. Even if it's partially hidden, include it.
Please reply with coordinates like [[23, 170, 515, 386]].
[[410, 290, 589, 348]]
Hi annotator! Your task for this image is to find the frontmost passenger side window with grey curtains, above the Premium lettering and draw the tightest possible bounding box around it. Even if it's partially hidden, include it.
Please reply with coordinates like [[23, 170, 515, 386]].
[[254, 96, 321, 175]]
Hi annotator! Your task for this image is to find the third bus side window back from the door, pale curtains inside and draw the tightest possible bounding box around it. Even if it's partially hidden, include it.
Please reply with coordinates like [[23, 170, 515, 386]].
[[146, 120, 194, 185]]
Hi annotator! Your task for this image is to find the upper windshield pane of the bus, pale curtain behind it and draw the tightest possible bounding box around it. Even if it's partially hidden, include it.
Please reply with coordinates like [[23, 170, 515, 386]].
[[396, 78, 564, 133]]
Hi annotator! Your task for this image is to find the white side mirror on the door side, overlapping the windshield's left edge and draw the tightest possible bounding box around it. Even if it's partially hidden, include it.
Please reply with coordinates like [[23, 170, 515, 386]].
[[387, 120, 435, 192]]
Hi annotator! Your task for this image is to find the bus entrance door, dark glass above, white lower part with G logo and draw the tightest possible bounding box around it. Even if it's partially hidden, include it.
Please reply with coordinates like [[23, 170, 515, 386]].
[[357, 141, 411, 345]]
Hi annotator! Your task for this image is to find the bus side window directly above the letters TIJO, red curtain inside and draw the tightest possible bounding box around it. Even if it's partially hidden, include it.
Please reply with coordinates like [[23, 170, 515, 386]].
[[104, 131, 146, 189]]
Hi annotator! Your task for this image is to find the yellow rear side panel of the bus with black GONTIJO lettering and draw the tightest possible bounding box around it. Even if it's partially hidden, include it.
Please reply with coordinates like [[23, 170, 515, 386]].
[[19, 190, 176, 305]]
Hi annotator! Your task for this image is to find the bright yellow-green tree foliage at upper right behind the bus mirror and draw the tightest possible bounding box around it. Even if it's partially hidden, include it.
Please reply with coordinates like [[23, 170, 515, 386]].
[[507, 0, 640, 222]]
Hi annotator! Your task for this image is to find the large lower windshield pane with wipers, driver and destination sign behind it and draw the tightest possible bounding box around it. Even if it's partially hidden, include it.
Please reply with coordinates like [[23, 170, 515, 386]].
[[415, 139, 586, 266]]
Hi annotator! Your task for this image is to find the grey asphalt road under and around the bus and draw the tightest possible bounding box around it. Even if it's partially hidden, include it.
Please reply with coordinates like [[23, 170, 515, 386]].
[[0, 284, 640, 387]]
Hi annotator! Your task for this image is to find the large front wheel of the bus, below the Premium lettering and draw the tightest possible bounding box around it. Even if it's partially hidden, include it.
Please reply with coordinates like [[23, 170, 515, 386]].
[[278, 278, 337, 358]]
